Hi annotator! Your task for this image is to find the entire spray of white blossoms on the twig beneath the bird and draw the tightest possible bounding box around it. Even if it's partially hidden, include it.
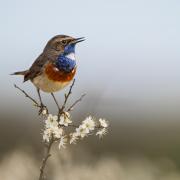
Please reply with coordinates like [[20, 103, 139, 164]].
[[43, 111, 109, 149]]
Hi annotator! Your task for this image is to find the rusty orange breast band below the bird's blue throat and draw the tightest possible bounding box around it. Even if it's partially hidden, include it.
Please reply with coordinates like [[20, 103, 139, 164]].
[[45, 63, 76, 82]]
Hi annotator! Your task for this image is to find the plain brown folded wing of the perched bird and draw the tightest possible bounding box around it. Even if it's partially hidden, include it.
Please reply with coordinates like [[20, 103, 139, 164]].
[[24, 53, 56, 81]]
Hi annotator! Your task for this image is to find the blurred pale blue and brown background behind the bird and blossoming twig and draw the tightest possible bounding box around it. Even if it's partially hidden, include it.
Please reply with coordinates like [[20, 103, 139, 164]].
[[0, 0, 180, 180]]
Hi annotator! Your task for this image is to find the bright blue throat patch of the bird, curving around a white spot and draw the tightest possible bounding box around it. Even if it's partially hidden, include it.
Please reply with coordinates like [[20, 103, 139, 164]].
[[56, 44, 76, 72]]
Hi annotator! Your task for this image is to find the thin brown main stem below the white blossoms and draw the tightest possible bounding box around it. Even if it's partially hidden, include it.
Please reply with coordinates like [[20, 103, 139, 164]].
[[39, 139, 54, 180]]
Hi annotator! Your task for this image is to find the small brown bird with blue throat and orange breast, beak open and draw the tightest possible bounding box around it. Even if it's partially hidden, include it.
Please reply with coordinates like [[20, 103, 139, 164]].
[[12, 35, 85, 112]]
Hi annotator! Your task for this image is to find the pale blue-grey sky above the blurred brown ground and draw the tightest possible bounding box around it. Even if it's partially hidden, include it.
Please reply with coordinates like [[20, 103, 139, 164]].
[[0, 0, 180, 121]]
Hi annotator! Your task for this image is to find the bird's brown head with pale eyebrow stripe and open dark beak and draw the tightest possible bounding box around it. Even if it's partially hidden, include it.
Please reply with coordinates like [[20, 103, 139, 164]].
[[44, 35, 85, 55]]
